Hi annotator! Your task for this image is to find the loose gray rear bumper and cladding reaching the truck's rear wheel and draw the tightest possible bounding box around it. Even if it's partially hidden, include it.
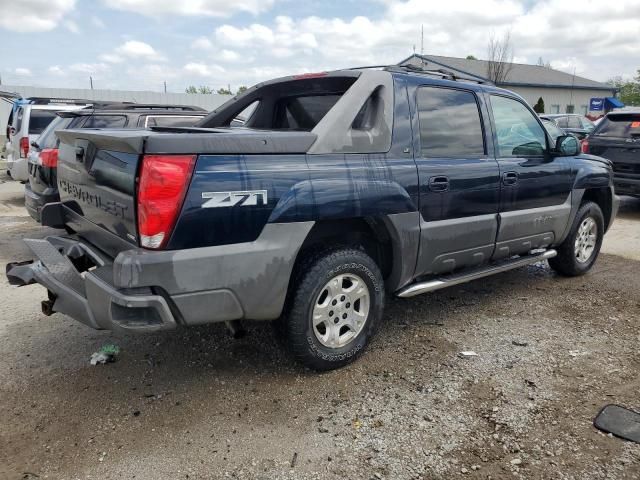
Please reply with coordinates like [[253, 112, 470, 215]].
[[7, 222, 314, 331]]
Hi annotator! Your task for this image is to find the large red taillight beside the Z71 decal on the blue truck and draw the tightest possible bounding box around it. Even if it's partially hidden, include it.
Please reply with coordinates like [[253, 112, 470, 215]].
[[138, 155, 196, 249]]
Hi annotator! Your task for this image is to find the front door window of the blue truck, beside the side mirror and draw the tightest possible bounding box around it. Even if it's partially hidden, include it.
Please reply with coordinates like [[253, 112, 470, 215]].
[[491, 95, 547, 157]]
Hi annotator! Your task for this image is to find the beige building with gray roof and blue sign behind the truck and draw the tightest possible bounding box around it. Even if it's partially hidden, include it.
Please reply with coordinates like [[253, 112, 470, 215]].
[[399, 54, 622, 116]]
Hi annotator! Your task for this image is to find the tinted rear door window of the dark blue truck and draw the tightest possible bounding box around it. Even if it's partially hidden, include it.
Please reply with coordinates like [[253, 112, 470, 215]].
[[418, 87, 486, 158]]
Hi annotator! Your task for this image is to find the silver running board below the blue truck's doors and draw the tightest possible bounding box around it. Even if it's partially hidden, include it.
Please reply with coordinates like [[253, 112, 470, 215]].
[[396, 250, 558, 298]]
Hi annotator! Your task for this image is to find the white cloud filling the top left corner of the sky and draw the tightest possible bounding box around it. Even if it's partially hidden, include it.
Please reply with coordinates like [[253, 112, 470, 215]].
[[0, 0, 76, 32]]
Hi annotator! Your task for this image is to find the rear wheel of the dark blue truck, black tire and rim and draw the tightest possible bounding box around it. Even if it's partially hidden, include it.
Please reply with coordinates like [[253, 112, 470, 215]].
[[277, 248, 385, 371]]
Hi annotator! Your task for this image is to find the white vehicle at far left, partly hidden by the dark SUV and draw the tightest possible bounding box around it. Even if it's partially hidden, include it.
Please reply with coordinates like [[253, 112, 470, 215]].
[[6, 99, 86, 182]]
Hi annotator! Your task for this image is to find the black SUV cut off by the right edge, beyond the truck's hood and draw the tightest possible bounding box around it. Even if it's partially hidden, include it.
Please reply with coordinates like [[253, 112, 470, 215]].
[[582, 109, 640, 197]]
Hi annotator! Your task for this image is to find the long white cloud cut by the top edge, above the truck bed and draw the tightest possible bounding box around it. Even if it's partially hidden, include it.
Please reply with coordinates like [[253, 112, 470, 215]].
[[104, 0, 275, 17]]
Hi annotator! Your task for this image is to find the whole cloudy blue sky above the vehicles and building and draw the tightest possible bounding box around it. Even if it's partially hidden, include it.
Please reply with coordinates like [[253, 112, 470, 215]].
[[0, 0, 640, 92]]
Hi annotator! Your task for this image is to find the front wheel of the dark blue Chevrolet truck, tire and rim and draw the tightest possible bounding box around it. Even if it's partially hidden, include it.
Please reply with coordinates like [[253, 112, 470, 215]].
[[549, 202, 604, 277]]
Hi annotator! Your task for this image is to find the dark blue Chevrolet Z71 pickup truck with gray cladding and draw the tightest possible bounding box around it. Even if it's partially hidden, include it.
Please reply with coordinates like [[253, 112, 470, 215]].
[[7, 67, 618, 370]]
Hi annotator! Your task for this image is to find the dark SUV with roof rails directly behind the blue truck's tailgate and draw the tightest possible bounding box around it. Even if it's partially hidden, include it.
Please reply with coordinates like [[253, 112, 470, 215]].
[[24, 103, 207, 222]]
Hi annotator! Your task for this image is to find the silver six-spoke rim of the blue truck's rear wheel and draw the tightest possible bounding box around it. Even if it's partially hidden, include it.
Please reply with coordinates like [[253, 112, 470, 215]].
[[312, 273, 371, 348]]
